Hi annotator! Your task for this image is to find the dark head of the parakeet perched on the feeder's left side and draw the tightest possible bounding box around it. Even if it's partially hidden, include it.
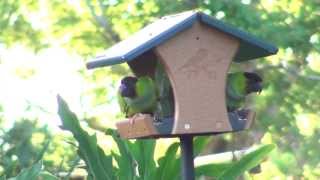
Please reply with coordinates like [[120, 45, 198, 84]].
[[119, 76, 138, 98]]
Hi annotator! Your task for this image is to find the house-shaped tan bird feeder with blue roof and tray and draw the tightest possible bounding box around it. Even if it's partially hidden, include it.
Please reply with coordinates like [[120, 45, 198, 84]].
[[87, 11, 277, 138]]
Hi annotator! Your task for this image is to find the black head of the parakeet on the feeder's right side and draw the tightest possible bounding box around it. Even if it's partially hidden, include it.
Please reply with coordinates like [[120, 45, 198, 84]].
[[244, 72, 262, 94]]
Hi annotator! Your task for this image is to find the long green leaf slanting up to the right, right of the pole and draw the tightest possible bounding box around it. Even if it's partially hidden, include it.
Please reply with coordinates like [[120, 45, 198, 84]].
[[218, 144, 275, 179]]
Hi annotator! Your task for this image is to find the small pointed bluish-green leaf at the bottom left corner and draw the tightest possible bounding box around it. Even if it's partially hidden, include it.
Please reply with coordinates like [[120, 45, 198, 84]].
[[9, 161, 42, 180]]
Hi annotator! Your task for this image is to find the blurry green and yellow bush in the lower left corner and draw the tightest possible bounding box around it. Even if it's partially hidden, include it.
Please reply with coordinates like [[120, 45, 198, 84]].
[[0, 120, 75, 178]]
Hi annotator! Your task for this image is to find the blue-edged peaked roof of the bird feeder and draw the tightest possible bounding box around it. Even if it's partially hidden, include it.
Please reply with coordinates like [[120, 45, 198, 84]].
[[87, 11, 278, 69]]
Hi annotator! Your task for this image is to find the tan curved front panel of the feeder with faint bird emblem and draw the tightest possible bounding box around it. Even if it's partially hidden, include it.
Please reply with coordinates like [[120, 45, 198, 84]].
[[156, 22, 239, 134]]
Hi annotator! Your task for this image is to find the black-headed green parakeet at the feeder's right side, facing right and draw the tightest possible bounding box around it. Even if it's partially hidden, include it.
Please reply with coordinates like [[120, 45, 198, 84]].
[[226, 72, 262, 112]]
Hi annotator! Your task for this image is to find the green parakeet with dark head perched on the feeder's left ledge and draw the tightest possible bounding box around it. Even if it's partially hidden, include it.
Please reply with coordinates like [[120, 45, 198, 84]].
[[117, 76, 157, 117]]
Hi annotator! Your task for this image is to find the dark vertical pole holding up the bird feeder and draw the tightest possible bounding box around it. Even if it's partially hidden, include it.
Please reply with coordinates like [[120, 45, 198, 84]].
[[180, 135, 195, 180]]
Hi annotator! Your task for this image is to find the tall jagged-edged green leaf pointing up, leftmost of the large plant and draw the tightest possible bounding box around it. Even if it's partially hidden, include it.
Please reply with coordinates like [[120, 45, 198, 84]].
[[57, 96, 116, 180]]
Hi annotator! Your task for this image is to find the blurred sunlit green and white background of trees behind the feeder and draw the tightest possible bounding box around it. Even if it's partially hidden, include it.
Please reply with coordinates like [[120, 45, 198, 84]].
[[0, 0, 320, 179]]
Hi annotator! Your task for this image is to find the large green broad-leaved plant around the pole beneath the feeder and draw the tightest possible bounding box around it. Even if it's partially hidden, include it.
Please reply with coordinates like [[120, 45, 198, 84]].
[[57, 96, 274, 180]]
